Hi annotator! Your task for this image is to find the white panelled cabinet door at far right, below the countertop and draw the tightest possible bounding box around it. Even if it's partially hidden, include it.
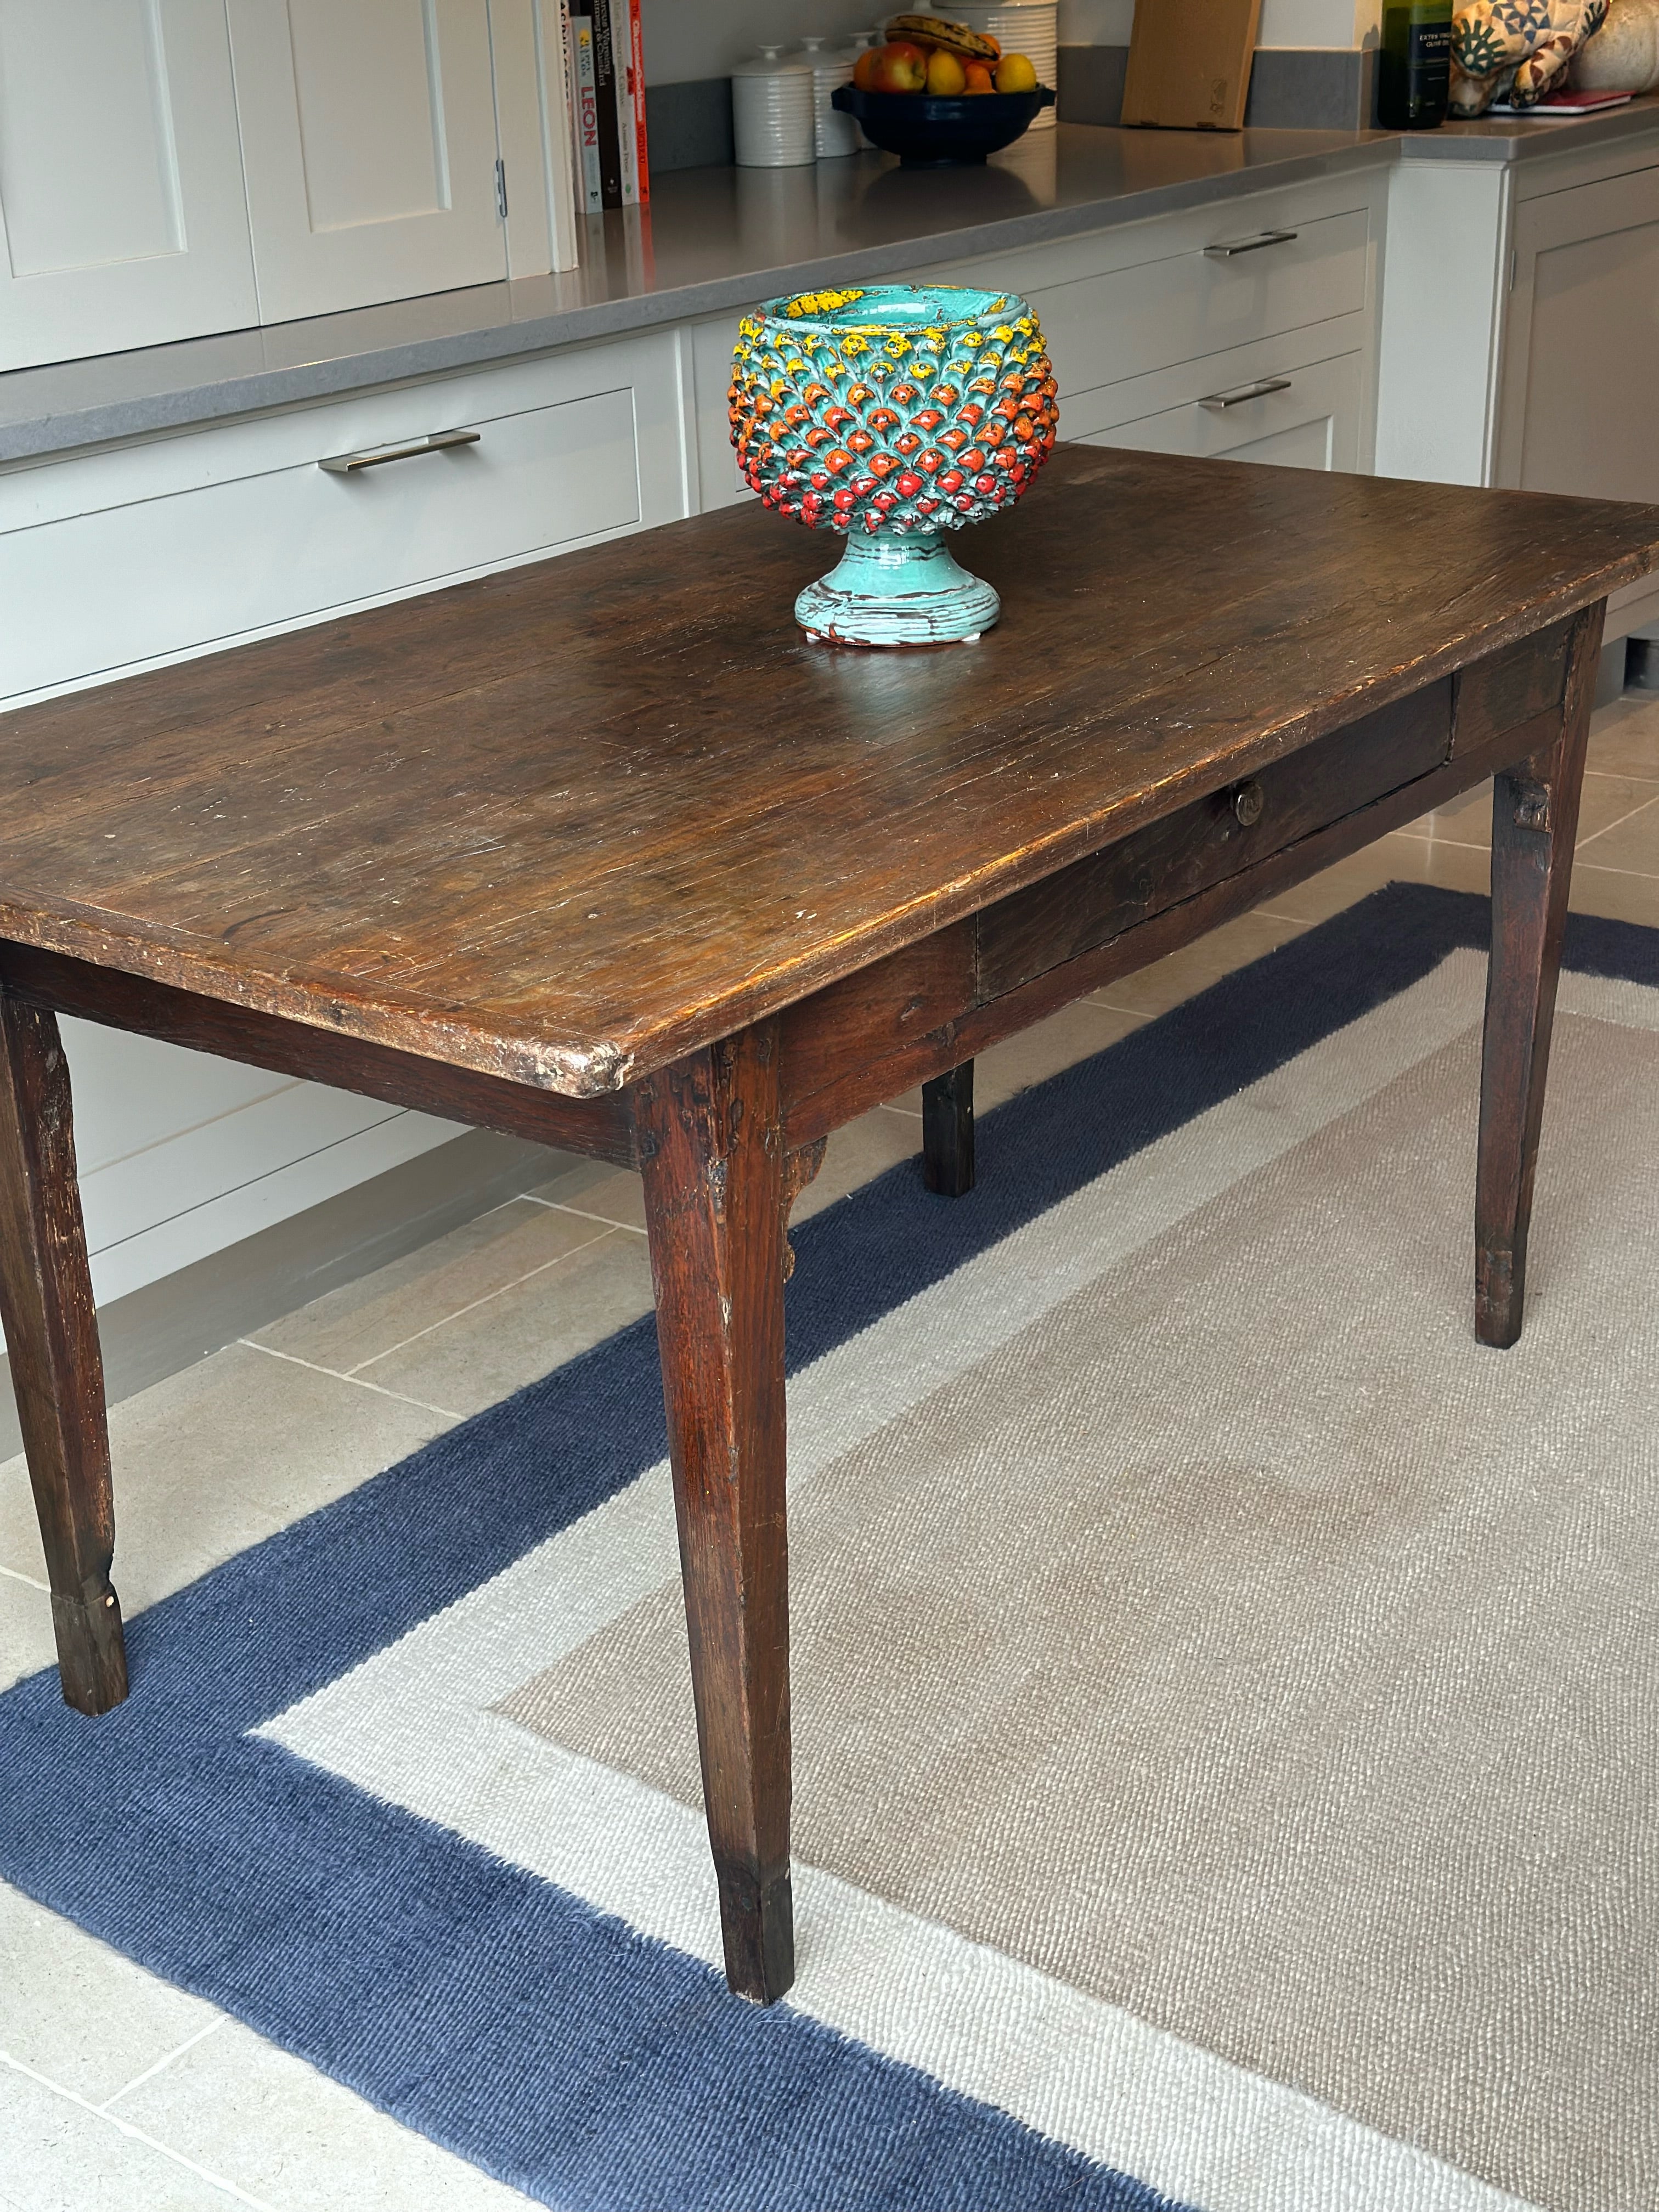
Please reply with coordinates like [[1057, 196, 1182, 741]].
[[1496, 168, 1659, 500]]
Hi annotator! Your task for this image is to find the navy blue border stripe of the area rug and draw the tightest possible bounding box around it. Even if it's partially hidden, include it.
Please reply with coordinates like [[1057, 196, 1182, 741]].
[[0, 885, 1659, 2212]]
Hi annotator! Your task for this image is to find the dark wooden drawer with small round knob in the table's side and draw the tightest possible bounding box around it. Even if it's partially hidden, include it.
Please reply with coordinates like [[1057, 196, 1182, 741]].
[[978, 679, 1451, 1000]]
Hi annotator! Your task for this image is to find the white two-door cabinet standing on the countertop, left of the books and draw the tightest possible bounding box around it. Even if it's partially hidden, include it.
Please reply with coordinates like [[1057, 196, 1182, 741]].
[[0, 0, 577, 369]]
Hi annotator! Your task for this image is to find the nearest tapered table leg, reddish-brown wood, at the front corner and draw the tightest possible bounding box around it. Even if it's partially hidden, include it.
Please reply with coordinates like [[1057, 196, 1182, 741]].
[[635, 1022, 794, 2004]]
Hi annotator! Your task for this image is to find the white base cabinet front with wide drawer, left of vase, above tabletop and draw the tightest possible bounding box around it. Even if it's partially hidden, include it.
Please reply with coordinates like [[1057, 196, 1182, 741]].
[[0, 332, 686, 706]]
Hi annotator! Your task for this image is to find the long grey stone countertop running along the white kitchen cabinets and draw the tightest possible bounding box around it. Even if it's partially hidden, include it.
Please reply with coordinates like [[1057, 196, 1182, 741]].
[[0, 99, 1659, 462]]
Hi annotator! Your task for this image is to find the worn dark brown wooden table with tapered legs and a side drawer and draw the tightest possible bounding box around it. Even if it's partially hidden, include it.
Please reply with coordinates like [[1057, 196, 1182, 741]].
[[0, 447, 1659, 2000]]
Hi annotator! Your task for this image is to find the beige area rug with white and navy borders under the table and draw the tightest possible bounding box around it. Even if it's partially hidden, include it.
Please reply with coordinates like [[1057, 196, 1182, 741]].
[[0, 885, 1659, 2212]]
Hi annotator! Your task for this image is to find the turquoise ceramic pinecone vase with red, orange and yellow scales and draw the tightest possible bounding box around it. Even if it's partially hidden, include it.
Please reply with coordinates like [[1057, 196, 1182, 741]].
[[730, 285, 1059, 646]]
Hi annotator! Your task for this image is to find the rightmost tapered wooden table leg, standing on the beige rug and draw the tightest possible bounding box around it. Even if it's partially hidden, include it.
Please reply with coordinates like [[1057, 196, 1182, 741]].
[[1475, 606, 1604, 1347]]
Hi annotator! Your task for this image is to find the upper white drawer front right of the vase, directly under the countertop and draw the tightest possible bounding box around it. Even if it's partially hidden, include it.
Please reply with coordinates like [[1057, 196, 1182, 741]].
[[1031, 208, 1369, 400]]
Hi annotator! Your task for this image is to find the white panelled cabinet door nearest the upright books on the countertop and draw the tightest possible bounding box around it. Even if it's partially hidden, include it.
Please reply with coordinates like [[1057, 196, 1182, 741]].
[[230, 0, 506, 323]]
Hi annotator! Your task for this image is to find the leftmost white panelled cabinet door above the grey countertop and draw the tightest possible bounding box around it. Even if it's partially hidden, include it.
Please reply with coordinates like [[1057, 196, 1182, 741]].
[[0, 0, 259, 369]]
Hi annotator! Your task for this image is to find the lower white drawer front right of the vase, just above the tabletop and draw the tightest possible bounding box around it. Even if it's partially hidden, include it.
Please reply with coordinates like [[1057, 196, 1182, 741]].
[[1079, 354, 1363, 469]]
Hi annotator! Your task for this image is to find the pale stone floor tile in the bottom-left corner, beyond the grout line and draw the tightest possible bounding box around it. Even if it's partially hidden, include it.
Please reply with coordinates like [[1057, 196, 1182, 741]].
[[0, 2057, 250, 2212]]
